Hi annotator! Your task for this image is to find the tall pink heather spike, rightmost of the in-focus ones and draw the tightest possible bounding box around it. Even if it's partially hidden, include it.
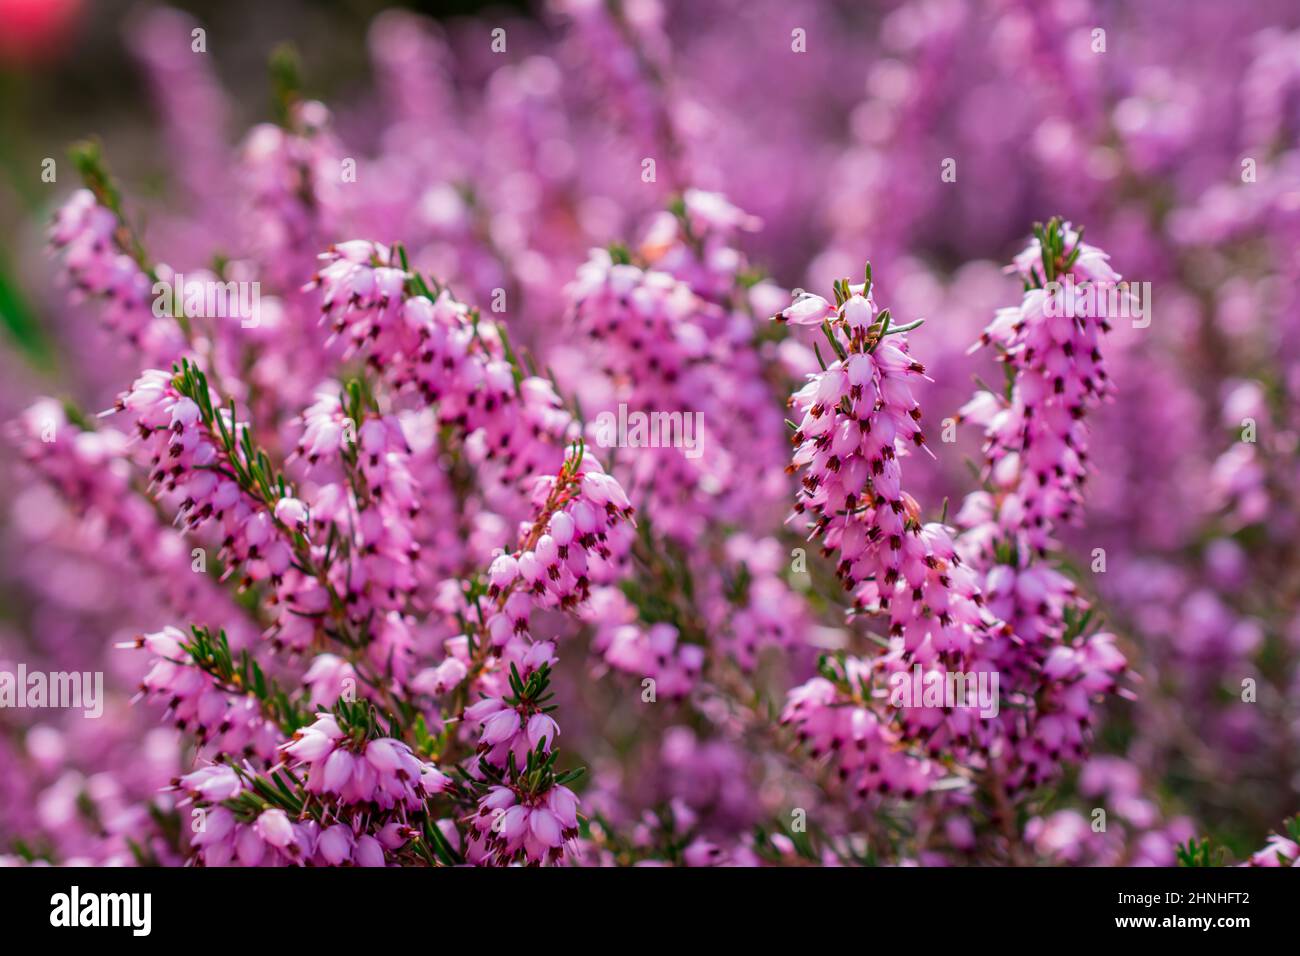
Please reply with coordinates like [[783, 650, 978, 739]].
[[958, 221, 1126, 792]]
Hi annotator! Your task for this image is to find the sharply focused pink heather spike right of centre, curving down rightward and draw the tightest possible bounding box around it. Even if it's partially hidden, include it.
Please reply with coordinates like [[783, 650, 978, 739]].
[[790, 277, 991, 659]]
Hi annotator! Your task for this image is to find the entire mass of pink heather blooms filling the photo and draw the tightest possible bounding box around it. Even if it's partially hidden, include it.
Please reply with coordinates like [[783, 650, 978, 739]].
[[0, 0, 1300, 866]]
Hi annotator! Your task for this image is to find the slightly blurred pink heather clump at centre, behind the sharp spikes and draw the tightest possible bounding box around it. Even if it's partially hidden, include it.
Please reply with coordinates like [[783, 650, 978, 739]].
[[566, 223, 785, 542]]
